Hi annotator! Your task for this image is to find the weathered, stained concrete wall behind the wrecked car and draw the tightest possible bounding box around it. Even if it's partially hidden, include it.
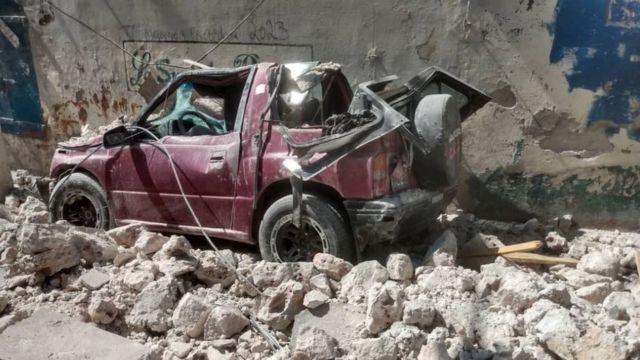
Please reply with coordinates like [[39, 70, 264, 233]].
[[0, 0, 640, 227]]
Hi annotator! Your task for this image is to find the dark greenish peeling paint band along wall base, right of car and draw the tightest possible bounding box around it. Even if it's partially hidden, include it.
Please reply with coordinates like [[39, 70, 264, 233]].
[[469, 166, 640, 227]]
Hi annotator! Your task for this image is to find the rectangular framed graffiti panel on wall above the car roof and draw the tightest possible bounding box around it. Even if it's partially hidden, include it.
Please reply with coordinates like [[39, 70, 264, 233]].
[[124, 41, 313, 100]]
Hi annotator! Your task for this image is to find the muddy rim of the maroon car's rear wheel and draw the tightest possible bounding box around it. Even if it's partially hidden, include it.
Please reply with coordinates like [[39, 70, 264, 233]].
[[269, 215, 329, 262]]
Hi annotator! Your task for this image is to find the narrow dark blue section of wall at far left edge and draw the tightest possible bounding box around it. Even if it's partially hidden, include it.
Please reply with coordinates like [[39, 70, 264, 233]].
[[0, 0, 44, 134]]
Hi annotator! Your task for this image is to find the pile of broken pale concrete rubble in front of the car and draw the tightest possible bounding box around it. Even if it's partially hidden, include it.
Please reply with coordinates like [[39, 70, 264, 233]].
[[0, 184, 640, 360]]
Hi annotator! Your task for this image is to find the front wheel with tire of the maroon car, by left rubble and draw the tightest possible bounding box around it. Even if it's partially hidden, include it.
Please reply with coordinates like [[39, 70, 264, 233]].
[[49, 173, 113, 230]]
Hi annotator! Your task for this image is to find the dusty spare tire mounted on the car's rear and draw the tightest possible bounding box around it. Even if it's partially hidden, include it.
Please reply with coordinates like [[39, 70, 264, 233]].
[[413, 94, 462, 190]]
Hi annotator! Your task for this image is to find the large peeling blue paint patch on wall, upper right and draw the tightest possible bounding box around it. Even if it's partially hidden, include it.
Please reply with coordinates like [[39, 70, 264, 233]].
[[550, 0, 640, 140]]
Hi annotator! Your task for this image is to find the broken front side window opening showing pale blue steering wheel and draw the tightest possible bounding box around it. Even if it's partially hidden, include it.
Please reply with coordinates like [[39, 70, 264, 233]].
[[141, 74, 246, 138]]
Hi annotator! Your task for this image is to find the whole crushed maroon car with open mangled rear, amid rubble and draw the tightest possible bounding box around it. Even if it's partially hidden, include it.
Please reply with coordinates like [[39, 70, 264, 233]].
[[49, 63, 490, 261]]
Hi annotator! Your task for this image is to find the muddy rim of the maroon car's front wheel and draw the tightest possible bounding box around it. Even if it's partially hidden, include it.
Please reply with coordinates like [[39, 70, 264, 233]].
[[59, 191, 102, 228]]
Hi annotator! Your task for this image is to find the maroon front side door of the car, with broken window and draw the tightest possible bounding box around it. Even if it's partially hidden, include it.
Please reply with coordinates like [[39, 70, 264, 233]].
[[108, 71, 248, 239]]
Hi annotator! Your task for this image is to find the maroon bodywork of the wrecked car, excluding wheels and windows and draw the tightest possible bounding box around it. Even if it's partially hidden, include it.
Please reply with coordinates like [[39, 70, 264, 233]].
[[50, 64, 486, 262]]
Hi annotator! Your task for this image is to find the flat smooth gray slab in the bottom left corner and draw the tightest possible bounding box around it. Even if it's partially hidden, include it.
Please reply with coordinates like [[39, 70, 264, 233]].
[[0, 308, 149, 360]]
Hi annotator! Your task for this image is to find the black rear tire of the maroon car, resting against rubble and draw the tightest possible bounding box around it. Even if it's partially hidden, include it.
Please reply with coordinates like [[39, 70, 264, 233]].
[[258, 194, 356, 262]]
